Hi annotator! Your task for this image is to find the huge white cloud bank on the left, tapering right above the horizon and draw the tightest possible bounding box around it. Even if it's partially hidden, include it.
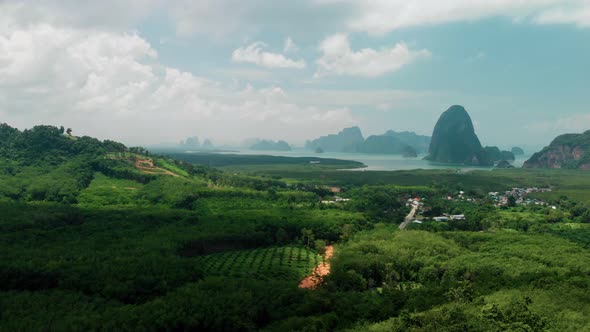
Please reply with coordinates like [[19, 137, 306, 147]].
[[0, 24, 356, 144]]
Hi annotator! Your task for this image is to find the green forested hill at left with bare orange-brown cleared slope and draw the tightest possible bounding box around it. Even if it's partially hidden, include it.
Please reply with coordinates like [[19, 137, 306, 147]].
[[0, 124, 214, 203]]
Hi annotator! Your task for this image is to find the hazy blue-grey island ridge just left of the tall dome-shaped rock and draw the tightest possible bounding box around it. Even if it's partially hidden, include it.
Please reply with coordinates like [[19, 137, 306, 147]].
[[305, 127, 430, 157]]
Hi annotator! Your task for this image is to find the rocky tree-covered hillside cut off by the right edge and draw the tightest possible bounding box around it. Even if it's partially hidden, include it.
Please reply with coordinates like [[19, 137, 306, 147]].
[[523, 130, 590, 170]]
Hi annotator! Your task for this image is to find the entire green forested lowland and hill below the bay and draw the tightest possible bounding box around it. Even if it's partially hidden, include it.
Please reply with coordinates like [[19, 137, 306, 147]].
[[0, 124, 590, 331]]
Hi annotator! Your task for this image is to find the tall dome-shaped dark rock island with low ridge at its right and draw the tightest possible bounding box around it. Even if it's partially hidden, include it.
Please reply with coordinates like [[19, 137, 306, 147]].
[[424, 105, 515, 166]]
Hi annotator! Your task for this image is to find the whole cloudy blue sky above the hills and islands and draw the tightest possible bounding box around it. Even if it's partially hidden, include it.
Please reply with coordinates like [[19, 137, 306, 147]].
[[0, 0, 590, 148]]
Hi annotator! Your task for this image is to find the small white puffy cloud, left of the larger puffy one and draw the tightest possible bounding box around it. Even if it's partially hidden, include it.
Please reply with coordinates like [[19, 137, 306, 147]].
[[232, 42, 305, 69]]
